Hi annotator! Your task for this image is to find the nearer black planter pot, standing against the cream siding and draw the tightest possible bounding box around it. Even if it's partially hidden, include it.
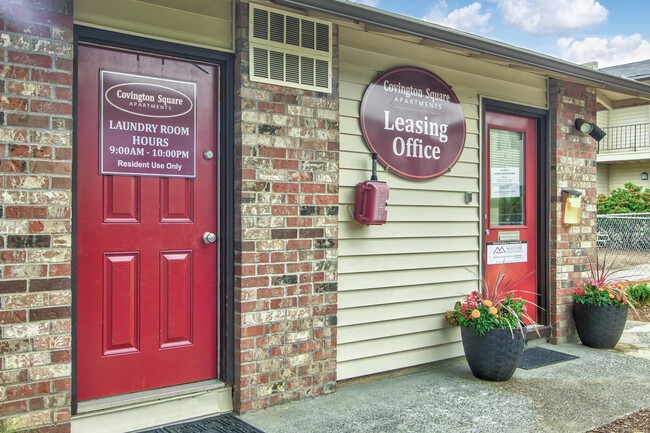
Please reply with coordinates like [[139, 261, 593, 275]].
[[460, 326, 525, 381]]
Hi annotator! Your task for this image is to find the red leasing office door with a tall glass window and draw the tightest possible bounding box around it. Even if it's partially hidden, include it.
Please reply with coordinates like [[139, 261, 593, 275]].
[[484, 111, 539, 320]]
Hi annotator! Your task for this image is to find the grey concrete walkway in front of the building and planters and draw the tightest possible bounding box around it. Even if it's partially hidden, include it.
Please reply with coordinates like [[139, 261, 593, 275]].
[[242, 321, 650, 433]]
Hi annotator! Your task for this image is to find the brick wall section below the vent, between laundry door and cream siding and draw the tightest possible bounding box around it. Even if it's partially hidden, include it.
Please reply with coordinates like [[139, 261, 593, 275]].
[[234, 2, 339, 412]]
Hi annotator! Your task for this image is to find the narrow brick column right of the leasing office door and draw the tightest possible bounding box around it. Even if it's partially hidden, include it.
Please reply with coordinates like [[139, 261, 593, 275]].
[[549, 80, 597, 343]]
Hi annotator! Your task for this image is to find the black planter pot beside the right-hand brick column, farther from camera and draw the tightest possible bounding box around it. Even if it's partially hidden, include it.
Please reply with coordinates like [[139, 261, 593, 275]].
[[573, 303, 628, 349]]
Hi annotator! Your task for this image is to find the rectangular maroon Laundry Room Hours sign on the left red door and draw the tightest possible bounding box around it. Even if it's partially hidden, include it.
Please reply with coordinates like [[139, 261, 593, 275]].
[[99, 71, 196, 178]]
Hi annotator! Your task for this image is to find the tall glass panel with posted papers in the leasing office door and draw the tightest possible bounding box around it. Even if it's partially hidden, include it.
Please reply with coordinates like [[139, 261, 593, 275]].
[[490, 129, 524, 227]]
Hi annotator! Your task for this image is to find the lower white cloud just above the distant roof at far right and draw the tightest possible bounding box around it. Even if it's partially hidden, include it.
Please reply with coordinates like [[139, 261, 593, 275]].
[[557, 33, 650, 68]]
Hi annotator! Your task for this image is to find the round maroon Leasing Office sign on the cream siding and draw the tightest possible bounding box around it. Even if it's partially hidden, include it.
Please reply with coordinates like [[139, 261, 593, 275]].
[[360, 66, 465, 180]]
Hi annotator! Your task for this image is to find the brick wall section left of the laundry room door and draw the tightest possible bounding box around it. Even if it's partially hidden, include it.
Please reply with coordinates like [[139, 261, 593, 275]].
[[0, 0, 73, 433]]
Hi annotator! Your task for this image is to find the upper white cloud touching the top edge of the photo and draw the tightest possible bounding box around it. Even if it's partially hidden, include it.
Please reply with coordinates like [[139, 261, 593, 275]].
[[497, 0, 609, 35]]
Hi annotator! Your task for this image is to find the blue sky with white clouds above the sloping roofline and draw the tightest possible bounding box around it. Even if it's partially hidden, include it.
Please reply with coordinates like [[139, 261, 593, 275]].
[[350, 0, 650, 68]]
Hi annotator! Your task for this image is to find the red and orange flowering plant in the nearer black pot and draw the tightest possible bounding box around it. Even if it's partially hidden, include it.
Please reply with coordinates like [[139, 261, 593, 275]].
[[445, 266, 534, 335]]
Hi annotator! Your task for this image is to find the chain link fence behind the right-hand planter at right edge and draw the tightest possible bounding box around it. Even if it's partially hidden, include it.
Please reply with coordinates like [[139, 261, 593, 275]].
[[597, 213, 650, 281]]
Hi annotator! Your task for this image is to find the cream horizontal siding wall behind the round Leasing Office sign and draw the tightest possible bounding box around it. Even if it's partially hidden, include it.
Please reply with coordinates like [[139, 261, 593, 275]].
[[337, 25, 547, 380]]
